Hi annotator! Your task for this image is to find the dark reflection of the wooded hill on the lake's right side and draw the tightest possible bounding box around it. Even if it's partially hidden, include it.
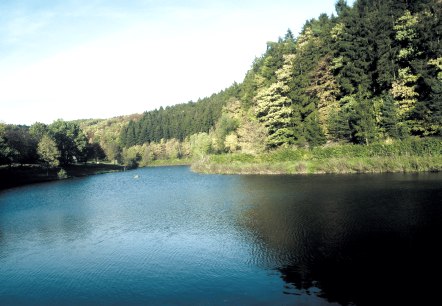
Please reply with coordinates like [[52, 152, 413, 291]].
[[239, 174, 442, 305]]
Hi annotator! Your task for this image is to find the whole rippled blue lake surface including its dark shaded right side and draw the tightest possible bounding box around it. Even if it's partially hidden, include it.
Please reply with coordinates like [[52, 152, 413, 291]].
[[0, 167, 442, 305]]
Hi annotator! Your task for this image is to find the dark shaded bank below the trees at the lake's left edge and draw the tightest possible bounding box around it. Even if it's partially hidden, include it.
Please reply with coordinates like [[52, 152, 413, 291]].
[[0, 163, 124, 190]]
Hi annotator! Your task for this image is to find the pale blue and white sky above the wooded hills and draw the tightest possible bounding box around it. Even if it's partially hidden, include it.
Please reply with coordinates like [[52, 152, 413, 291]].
[[0, 0, 353, 125]]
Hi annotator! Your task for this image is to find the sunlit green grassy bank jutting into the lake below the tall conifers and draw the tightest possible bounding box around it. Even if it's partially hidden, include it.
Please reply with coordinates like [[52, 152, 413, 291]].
[[192, 139, 442, 174]]
